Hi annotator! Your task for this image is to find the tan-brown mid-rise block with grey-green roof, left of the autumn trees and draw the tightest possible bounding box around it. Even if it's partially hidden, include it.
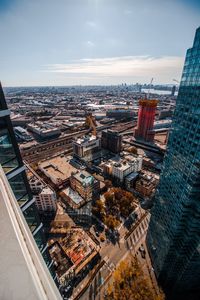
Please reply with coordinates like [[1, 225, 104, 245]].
[[70, 171, 100, 201]]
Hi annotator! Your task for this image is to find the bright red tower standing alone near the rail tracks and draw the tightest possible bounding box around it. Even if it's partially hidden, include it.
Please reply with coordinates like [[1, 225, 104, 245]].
[[135, 99, 158, 142]]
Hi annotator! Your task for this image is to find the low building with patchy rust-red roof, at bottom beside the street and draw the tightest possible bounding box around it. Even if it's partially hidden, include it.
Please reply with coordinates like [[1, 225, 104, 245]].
[[49, 225, 99, 286]]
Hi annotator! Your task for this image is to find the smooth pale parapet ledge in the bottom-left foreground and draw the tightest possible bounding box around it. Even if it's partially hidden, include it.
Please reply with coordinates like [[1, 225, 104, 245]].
[[0, 165, 62, 300]]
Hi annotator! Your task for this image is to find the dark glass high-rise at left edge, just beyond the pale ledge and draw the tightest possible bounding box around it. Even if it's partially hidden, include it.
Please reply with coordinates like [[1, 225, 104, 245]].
[[0, 84, 57, 288]]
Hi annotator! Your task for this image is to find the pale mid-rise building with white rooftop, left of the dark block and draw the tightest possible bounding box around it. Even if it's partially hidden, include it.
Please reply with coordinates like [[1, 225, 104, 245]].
[[73, 135, 101, 162]]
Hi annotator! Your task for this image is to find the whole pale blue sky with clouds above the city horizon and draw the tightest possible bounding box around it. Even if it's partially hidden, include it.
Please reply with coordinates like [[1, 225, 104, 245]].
[[0, 0, 200, 86]]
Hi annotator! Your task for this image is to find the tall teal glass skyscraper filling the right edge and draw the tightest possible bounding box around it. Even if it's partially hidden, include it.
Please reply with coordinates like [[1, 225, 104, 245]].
[[147, 28, 200, 300]]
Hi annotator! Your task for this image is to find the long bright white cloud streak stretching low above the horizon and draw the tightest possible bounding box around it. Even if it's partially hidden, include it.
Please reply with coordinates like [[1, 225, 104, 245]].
[[46, 54, 183, 83]]
